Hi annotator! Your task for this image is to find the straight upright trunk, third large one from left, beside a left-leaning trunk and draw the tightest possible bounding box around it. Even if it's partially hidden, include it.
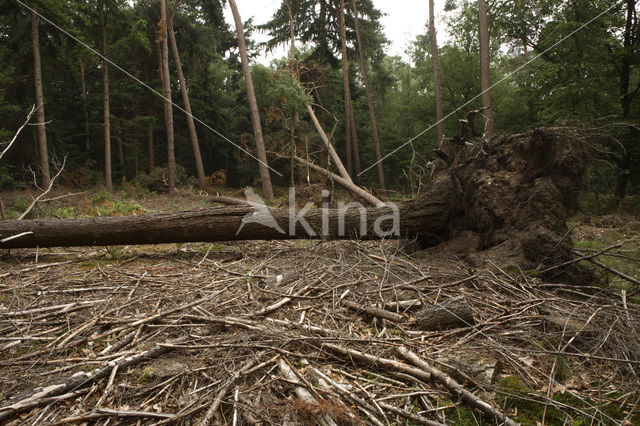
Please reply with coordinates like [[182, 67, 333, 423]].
[[159, 0, 176, 194]]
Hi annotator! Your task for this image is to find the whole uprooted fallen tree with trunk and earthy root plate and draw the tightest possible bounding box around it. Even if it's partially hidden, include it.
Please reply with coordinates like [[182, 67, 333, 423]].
[[0, 127, 590, 266]]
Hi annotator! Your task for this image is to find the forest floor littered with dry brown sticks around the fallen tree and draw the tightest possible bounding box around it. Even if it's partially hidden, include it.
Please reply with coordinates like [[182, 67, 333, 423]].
[[0, 187, 640, 425]]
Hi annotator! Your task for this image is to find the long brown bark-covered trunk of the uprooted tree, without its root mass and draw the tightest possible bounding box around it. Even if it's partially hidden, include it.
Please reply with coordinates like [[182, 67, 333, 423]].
[[0, 201, 446, 248]]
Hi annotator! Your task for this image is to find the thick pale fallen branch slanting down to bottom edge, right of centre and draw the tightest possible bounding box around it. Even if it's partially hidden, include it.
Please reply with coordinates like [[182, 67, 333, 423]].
[[396, 346, 517, 426]]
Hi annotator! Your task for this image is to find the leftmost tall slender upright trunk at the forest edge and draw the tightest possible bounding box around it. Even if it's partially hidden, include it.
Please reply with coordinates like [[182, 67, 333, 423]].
[[31, 11, 51, 188]]
